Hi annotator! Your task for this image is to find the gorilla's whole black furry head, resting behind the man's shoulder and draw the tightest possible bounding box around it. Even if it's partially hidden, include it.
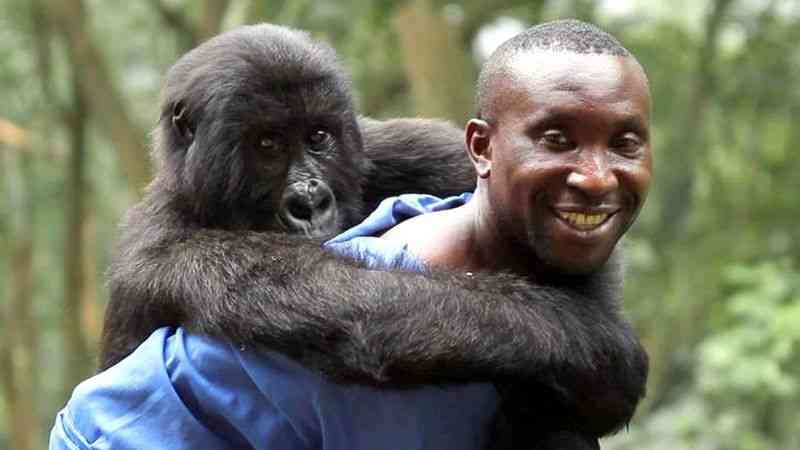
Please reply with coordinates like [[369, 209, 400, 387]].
[[152, 24, 365, 237]]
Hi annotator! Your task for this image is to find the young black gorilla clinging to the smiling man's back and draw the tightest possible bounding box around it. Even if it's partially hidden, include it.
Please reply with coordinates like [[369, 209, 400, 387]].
[[92, 25, 646, 446]]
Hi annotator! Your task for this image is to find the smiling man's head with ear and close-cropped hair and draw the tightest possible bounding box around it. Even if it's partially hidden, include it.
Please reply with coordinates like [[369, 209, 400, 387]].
[[466, 20, 651, 273]]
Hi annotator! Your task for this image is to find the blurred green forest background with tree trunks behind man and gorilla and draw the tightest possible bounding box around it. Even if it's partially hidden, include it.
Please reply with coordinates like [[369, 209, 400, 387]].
[[0, 0, 800, 450]]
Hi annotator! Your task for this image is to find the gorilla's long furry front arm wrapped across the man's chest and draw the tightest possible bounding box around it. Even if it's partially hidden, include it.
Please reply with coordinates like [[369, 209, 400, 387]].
[[101, 197, 646, 432]]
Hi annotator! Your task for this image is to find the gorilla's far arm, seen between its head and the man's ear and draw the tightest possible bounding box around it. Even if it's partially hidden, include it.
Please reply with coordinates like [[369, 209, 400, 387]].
[[358, 117, 476, 212]]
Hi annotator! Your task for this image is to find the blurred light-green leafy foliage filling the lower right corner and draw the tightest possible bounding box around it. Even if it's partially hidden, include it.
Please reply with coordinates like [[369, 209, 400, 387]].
[[608, 260, 800, 450]]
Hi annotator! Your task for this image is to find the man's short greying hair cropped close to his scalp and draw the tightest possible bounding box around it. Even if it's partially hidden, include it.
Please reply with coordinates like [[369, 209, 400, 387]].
[[476, 19, 632, 117]]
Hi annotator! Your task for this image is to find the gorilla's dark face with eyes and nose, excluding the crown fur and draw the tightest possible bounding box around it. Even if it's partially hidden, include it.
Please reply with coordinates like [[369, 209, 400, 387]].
[[231, 83, 361, 237]]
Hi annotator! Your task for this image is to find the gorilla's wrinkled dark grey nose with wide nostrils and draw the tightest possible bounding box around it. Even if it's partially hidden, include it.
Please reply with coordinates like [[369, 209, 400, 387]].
[[280, 179, 336, 236]]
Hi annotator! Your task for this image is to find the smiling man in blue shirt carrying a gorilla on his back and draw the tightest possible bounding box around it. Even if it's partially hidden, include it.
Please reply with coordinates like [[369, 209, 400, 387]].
[[51, 21, 651, 449]]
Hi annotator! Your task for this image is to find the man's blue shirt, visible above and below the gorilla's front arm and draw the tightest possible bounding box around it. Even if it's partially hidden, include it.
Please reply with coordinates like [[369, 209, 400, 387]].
[[50, 194, 497, 450]]
